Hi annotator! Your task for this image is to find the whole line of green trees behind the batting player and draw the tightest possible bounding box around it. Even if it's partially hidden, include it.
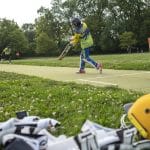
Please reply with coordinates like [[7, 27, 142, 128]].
[[0, 0, 150, 56]]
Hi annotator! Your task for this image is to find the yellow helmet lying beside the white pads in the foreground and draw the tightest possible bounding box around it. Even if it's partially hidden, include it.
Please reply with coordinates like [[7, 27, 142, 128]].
[[128, 94, 150, 139]]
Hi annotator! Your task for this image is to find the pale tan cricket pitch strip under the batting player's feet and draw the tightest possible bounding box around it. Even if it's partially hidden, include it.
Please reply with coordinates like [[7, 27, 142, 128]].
[[0, 64, 150, 93]]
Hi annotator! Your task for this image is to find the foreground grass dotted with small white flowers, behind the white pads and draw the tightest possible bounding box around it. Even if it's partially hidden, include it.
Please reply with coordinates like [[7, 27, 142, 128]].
[[0, 72, 143, 136]]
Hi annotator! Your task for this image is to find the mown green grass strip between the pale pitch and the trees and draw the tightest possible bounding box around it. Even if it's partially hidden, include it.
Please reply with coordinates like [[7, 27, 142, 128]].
[[8, 53, 150, 71]]
